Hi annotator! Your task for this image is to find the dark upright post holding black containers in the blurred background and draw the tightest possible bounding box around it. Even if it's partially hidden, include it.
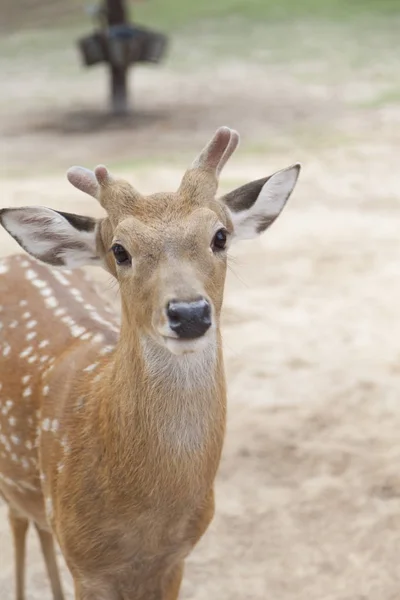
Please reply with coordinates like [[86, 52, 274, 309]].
[[105, 0, 128, 115]]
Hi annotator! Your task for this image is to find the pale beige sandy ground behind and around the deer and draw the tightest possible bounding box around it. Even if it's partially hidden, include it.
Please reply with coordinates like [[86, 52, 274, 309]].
[[0, 15, 400, 600]]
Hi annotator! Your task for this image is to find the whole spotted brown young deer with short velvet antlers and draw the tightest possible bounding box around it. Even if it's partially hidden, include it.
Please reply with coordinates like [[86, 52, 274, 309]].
[[0, 127, 300, 600]]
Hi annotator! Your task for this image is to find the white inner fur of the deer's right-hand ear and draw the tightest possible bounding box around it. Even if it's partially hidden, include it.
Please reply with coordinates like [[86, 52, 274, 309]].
[[231, 164, 300, 240]]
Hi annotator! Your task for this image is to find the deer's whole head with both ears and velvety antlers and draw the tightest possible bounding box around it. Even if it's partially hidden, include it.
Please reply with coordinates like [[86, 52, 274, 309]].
[[0, 128, 300, 354]]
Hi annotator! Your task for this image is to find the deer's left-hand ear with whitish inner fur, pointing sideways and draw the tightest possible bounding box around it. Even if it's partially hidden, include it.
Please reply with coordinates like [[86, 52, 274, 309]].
[[0, 206, 100, 268]]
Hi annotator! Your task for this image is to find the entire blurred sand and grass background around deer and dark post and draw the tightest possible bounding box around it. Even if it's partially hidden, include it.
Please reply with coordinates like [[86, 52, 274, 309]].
[[0, 0, 400, 600]]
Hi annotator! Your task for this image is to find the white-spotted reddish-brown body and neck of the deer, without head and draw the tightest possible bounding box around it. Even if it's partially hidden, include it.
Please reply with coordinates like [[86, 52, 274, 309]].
[[0, 256, 225, 598]]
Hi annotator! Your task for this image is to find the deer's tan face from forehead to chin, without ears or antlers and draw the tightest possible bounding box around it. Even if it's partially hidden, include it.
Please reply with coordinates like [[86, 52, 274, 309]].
[[100, 192, 232, 352]]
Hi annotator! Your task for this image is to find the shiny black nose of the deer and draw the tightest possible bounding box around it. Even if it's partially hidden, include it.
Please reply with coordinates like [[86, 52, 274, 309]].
[[167, 298, 211, 339]]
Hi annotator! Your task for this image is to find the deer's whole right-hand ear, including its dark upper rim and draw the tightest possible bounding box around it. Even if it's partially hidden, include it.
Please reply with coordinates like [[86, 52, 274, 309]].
[[221, 164, 300, 240]]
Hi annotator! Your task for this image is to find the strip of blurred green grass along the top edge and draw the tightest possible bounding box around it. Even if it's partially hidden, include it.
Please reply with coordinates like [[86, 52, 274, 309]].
[[0, 0, 400, 34]]
